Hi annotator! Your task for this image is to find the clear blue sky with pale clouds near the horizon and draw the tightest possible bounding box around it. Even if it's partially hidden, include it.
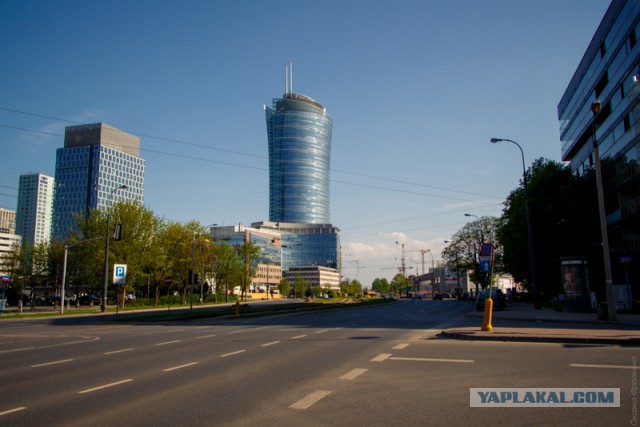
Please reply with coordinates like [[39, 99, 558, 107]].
[[0, 0, 609, 286]]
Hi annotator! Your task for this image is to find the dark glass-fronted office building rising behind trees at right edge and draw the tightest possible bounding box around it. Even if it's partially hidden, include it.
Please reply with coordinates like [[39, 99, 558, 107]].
[[558, 0, 640, 296]]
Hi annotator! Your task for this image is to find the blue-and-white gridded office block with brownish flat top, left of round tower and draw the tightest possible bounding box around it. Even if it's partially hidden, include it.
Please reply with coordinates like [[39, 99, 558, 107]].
[[53, 123, 145, 240]]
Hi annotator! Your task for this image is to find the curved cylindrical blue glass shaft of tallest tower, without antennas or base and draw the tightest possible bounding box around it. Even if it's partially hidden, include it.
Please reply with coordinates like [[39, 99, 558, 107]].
[[265, 93, 333, 224]]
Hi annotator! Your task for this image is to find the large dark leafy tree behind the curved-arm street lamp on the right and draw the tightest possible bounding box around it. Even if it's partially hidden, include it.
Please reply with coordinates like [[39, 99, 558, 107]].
[[498, 158, 602, 297]]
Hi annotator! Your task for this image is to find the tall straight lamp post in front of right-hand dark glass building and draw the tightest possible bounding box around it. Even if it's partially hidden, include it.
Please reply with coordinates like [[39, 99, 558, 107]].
[[591, 100, 618, 321]]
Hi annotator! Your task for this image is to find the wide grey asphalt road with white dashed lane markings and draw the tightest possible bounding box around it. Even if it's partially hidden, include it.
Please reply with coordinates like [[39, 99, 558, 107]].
[[0, 300, 639, 426]]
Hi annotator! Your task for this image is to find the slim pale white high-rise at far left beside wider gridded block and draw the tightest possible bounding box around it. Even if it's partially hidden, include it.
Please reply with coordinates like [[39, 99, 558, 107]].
[[16, 173, 55, 246]]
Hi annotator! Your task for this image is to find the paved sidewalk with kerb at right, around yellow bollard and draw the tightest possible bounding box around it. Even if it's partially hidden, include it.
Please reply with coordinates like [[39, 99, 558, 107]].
[[440, 303, 640, 346]]
